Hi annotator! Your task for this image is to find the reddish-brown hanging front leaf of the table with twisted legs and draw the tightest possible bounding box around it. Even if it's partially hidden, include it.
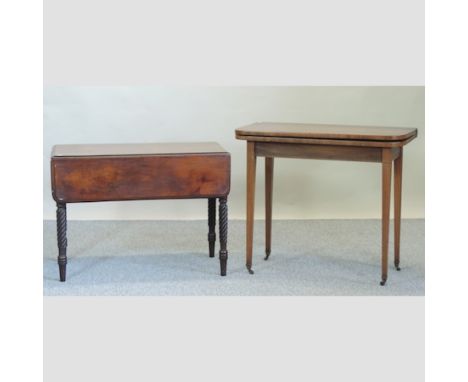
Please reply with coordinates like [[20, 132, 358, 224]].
[[51, 153, 230, 203]]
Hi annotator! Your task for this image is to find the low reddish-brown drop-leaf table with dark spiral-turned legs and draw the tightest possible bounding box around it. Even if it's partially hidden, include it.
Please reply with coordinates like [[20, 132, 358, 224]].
[[51, 142, 231, 281]]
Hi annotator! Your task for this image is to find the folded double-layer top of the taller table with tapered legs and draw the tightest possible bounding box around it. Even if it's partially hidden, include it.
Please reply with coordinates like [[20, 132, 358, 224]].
[[236, 122, 417, 142]]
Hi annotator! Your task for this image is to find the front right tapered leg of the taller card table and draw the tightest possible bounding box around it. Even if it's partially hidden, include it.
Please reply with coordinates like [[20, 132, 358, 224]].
[[380, 149, 392, 285]]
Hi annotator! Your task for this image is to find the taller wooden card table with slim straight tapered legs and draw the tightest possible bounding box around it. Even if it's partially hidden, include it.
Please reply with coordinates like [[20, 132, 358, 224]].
[[236, 122, 417, 285]]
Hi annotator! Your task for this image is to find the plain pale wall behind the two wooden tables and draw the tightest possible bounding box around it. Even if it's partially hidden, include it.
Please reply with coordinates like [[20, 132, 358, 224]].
[[43, 86, 424, 219]]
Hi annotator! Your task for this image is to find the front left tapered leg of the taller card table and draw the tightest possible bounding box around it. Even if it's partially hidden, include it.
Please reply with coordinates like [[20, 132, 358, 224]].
[[245, 142, 257, 274]]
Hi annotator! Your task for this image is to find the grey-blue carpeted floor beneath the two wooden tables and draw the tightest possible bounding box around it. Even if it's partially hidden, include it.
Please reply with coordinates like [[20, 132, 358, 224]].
[[44, 220, 424, 296]]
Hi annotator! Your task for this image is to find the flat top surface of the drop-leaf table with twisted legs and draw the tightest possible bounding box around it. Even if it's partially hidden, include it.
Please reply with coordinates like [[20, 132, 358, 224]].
[[52, 142, 227, 157]]
